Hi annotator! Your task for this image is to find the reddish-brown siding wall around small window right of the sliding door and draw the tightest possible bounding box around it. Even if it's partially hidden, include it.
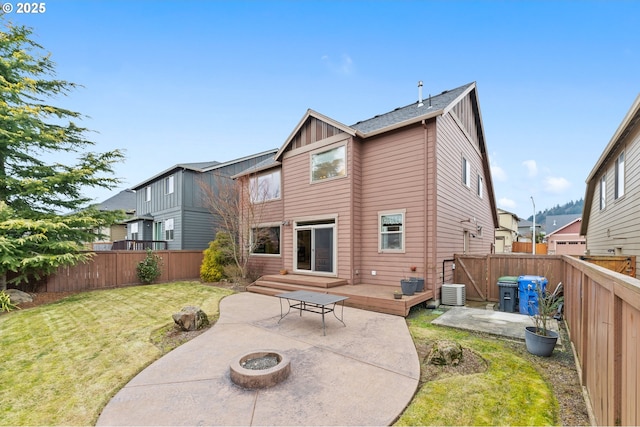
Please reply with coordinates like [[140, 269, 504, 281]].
[[356, 125, 427, 287]]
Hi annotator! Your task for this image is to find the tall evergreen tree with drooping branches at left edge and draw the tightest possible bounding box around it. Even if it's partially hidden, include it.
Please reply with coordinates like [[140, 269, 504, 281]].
[[0, 17, 124, 289]]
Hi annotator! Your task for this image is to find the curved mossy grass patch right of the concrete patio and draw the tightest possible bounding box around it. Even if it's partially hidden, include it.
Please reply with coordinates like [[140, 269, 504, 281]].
[[395, 310, 559, 426]]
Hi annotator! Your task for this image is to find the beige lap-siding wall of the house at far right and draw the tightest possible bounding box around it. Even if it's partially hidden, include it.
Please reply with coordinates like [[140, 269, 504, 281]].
[[587, 120, 640, 271]]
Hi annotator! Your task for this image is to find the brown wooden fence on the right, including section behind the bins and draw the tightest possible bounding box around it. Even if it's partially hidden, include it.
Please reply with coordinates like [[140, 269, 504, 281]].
[[455, 255, 640, 425]]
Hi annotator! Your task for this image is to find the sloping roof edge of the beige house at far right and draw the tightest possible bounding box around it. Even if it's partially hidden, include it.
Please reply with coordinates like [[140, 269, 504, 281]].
[[580, 95, 640, 236]]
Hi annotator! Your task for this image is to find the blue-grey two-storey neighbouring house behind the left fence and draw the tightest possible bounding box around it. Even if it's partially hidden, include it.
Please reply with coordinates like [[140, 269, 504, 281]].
[[124, 150, 276, 250]]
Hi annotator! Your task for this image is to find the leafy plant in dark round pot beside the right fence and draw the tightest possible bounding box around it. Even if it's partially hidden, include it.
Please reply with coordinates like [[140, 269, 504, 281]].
[[524, 283, 563, 357]]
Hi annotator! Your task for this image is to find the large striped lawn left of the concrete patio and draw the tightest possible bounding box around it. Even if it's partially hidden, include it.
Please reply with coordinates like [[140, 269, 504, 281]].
[[0, 282, 232, 425]]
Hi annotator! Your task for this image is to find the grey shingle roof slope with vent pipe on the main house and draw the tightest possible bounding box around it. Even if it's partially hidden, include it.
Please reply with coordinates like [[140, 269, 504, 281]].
[[351, 83, 473, 133]]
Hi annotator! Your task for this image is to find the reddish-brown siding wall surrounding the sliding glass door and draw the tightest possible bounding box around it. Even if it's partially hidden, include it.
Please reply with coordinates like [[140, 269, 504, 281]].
[[281, 134, 353, 278]]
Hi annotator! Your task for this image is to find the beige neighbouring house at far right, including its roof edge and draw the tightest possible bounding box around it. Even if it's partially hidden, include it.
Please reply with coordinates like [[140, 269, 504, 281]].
[[580, 95, 640, 271]]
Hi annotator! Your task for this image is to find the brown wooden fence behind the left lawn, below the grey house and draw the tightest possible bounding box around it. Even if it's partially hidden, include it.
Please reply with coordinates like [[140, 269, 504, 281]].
[[42, 251, 203, 292]]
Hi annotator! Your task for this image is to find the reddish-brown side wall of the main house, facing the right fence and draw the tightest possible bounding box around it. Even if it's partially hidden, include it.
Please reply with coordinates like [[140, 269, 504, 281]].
[[434, 110, 495, 285]]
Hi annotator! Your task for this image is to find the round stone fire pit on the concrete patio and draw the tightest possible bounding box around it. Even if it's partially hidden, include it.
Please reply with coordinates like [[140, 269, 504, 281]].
[[229, 350, 291, 388]]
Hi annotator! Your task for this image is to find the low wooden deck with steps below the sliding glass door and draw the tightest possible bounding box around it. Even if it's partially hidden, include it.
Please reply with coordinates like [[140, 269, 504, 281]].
[[247, 274, 433, 317]]
